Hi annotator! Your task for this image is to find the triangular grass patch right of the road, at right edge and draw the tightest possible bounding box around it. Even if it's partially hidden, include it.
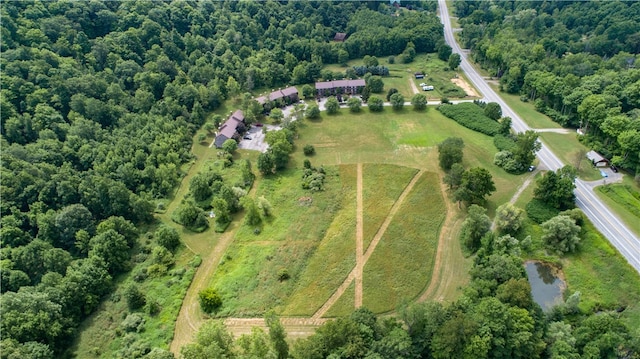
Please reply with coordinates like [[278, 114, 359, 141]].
[[596, 181, 640, 236]]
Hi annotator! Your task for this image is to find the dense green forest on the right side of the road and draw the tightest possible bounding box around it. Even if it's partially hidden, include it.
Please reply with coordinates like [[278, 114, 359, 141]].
[[455, 1, 640, 173]]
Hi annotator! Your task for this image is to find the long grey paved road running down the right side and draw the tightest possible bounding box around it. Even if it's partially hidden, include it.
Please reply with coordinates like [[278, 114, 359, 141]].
[[438, 0, 640, 272]]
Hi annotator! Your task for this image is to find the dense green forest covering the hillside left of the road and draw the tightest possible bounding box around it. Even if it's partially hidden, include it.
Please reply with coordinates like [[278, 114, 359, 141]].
[[0, 1, 442, 358]]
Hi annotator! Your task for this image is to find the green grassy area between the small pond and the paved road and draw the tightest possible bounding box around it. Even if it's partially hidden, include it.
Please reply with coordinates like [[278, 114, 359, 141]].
[[562, 220, 640, 328]]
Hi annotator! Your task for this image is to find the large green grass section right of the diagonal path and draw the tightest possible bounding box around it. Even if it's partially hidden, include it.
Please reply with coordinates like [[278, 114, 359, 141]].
[[363, 172, 446, 313]]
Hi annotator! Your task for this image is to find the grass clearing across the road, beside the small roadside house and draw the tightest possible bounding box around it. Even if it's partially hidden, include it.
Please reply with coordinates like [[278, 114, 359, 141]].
[[540, 132, 602, 181]]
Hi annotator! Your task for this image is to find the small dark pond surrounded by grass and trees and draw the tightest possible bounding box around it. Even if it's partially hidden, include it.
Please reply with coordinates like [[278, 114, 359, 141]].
[[525, 261, 566, 311]]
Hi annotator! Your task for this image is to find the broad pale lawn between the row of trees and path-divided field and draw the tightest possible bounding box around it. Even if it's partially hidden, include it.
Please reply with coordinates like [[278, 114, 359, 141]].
[[293, 107, 525, 218]]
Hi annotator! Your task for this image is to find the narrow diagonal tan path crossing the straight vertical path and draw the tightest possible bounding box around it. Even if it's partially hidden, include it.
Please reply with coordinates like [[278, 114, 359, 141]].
[[311, 170, 425, 320]]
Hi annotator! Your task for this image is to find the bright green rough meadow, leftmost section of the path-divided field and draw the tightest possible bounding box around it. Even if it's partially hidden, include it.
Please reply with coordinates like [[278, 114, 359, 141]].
[[210, 167, 355, 317]]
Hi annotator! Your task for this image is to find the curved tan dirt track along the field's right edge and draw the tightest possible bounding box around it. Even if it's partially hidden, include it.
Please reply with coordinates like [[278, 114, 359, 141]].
[[418, 179, 460, 302]]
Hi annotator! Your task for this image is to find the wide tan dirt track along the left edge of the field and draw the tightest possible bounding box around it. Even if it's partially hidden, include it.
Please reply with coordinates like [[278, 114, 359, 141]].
[[170, 223, 237, 357]]
